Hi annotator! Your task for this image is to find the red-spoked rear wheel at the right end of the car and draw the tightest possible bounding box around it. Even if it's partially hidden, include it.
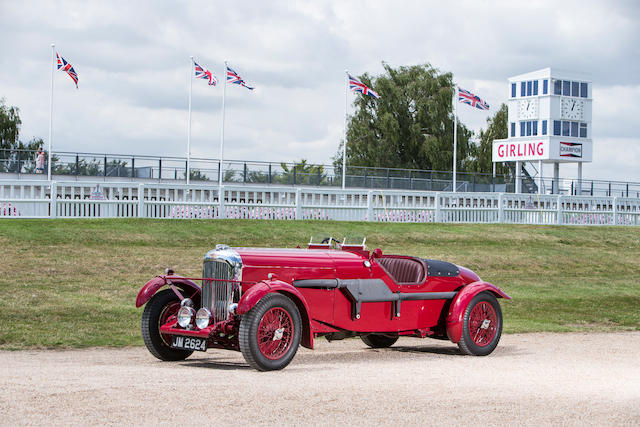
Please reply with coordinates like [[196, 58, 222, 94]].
[[458, 292, 502, 356]]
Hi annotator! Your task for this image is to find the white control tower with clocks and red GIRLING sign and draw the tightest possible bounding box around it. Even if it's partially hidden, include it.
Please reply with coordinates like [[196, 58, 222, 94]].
[[493, 68, 593, 194]]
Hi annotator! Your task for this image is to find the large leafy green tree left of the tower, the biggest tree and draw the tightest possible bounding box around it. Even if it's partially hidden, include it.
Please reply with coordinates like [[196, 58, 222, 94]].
[[334, 63, 472, 171]]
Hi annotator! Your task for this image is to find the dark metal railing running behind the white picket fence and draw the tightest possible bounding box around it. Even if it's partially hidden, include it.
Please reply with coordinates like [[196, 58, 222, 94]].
[[0, 150, 640, 198]]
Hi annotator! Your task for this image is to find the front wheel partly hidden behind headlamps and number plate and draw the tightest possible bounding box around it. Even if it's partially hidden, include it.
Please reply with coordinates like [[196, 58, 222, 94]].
[[142, 289, 193, 361]]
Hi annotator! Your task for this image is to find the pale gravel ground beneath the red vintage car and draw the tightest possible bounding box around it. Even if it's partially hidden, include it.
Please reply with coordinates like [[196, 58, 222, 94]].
[[0, 332, 640, 425]]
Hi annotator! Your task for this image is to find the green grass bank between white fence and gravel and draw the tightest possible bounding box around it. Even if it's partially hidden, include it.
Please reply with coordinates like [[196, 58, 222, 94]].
[[0, 219, 640, 349]]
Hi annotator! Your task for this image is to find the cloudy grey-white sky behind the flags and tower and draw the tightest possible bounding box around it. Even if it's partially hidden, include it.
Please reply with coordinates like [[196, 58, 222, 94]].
[[0, 0, 640, 181]]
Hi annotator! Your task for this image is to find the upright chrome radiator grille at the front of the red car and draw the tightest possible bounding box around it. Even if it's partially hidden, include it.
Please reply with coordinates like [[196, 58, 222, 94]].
[[202, 260, 234, 322]]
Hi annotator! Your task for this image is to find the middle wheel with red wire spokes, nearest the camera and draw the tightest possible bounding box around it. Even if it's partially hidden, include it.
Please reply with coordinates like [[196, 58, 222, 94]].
[[238, 294, 302, 371]]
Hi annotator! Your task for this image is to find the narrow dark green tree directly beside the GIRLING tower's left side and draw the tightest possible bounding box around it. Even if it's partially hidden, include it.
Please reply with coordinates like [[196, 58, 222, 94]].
[[468, 104, 509, 174]]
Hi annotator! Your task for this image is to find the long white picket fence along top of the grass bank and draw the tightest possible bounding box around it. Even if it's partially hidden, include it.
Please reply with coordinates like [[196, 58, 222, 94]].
[[0, 180, 640, 225]]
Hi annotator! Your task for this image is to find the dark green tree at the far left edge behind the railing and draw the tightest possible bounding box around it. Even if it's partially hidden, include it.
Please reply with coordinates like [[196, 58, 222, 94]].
[[0, 98, 43, 172]]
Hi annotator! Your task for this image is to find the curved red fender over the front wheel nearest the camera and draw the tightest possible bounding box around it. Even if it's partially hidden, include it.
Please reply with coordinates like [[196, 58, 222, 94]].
[[236, 280, 313, 349]]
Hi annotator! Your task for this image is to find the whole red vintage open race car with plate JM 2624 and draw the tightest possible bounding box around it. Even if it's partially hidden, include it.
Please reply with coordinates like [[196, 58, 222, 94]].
[[136, 237, 510, 371]]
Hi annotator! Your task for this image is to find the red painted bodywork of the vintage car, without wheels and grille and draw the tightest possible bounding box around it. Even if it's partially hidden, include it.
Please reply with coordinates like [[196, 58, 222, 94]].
[[136, 244, 510, 349]]
